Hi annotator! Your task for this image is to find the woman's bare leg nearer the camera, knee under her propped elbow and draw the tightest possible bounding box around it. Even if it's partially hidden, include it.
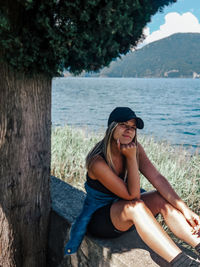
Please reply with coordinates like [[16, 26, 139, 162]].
[[110, 200, 181, 262]]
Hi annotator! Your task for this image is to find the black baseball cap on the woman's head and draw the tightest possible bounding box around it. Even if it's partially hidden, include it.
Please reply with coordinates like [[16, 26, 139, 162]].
[[108, 107, 144, 129]]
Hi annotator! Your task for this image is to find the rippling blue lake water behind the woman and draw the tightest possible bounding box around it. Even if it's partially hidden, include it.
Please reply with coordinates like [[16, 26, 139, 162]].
[[52, 78, 200, 152]]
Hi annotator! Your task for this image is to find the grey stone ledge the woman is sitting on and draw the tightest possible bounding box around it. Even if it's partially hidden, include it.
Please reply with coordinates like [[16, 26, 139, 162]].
[[47, 177, 195, 267]]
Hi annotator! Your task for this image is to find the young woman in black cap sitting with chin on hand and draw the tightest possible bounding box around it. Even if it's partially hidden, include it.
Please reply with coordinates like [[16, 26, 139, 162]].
[[65, 107, 200, 266]]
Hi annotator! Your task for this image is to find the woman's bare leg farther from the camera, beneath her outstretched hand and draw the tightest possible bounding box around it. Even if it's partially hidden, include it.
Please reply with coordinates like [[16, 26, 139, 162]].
[[141, 192, 200, 247]]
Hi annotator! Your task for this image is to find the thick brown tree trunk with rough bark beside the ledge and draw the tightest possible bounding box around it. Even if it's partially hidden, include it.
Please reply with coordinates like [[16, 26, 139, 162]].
[[0, 64, 51, 267]]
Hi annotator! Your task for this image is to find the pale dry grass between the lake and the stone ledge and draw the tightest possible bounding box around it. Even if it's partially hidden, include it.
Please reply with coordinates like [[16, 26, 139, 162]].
[[51, 126, 200, 216]]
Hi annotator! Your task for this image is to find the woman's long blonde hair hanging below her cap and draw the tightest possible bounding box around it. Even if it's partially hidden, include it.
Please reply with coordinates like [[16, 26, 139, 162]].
[[86, 122, 138, 173]]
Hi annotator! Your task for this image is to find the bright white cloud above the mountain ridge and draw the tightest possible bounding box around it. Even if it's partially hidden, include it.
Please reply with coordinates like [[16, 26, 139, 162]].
[[139, 12, 200, 47]]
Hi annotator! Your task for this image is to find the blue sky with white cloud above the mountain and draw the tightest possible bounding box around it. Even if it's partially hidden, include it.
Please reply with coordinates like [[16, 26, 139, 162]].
[[142, 0, 200, 45]]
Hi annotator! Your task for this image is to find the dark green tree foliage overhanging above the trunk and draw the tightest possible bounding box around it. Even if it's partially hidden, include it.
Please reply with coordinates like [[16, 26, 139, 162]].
[[0, 0, 174, 76]]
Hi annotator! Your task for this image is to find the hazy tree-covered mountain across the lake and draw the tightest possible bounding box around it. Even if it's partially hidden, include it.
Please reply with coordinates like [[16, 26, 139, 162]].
[[95, 33, 200, 78]]
